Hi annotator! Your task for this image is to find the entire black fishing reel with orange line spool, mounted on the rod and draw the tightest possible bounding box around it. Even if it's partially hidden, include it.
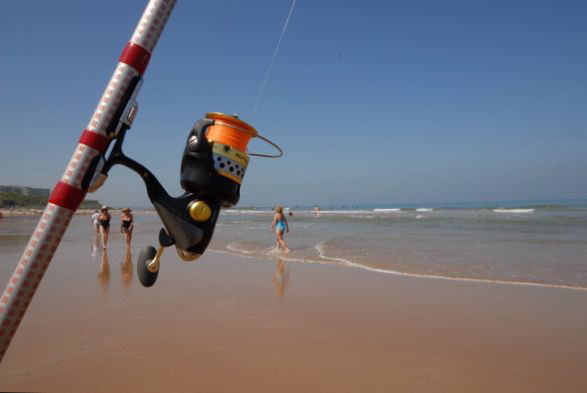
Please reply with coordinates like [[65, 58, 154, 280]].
[[89, 107, 283, 287]]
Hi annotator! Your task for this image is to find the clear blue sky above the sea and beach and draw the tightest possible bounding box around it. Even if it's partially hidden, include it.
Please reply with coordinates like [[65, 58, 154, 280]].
[[0, 0, 587, 207]]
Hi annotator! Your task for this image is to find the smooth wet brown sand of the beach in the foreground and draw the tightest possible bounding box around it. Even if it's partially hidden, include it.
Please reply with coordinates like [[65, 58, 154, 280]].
[[0, 222, 587, 393]]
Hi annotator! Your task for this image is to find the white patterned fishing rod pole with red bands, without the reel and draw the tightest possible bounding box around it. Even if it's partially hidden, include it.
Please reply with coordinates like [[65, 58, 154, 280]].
[[0, 0, 175, 360]]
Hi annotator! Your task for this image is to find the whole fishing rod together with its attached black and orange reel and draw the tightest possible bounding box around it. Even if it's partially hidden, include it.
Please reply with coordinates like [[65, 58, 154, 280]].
[[0, 0, 283, 361]]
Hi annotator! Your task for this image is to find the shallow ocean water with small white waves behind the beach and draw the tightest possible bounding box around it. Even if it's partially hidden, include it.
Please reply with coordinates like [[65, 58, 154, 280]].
[[0, 200, 587, 290]]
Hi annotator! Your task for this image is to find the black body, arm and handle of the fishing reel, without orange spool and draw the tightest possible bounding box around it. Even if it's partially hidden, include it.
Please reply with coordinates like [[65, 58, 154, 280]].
[[98, 112, 248, 286]]
